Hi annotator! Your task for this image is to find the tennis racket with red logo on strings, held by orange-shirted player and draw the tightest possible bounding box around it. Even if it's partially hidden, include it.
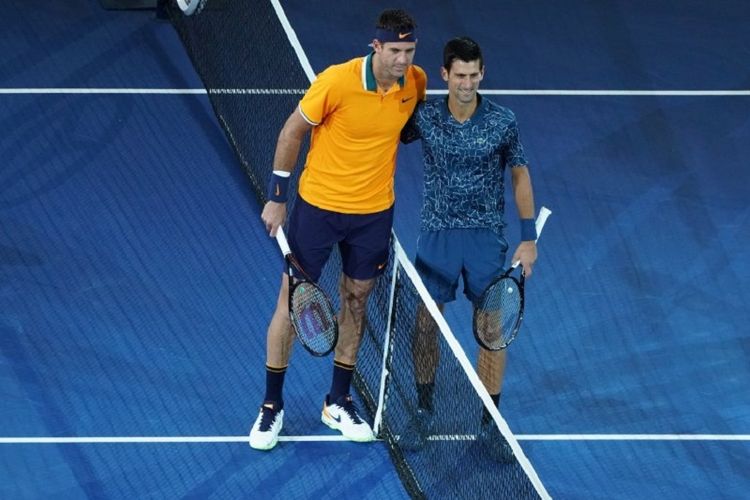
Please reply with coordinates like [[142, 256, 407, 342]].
[[276, 227, 339, 356]]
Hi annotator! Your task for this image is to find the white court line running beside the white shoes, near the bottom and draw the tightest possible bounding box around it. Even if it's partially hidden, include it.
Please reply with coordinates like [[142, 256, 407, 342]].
[[0, 434, 750, 444]]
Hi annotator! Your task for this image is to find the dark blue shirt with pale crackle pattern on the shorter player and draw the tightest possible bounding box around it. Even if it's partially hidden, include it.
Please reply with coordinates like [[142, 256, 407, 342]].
[[401, 94, 528, 231]]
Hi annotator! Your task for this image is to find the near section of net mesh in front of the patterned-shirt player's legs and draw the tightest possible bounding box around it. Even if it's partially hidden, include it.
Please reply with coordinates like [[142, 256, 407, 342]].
[[346, 237, 540, 499]]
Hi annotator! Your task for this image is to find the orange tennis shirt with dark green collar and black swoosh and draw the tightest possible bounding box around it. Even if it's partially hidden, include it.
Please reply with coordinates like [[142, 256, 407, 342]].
[[299, 54, 427, 214]]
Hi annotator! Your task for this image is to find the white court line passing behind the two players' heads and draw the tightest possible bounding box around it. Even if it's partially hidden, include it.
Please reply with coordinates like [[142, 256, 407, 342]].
[[0, 88, 750, 97]]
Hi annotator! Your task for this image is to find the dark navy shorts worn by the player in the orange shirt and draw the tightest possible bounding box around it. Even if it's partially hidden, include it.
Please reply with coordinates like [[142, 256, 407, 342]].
[[287, 196, 393, 281]]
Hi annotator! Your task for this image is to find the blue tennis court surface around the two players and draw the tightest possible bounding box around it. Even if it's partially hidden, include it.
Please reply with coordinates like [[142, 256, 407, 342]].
[[0, 0, 750, 499]]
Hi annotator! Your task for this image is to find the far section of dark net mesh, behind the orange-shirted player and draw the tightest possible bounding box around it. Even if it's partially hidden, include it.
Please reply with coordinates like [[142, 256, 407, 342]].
[[166, 0, 310, 202]]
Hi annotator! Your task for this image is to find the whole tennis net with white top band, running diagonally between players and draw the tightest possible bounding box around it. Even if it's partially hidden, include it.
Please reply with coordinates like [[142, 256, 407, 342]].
[[168, 0, 549, 499]]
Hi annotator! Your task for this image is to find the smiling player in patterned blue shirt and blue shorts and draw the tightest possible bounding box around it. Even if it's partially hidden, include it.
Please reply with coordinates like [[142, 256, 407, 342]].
[[401, 37, 537, 458]]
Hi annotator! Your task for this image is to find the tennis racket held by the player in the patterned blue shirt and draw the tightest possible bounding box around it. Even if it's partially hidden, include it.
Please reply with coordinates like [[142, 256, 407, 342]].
[[472, 207, 552, 351]]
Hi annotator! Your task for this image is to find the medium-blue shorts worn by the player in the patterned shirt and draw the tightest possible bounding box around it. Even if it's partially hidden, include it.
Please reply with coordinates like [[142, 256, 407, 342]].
[[415, 229, 508, 304]]
